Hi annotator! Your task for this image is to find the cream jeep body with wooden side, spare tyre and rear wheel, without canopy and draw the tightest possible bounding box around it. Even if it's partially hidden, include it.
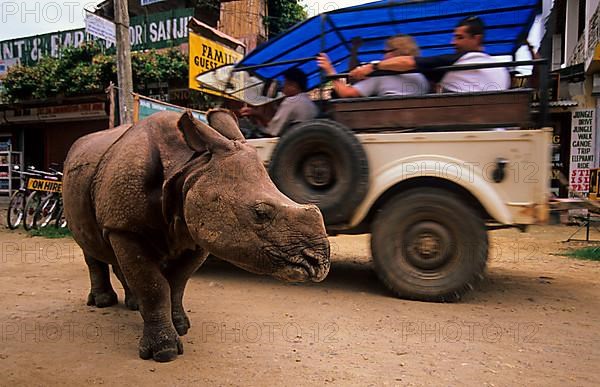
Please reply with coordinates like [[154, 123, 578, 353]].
[[249, 90, 552, 301]]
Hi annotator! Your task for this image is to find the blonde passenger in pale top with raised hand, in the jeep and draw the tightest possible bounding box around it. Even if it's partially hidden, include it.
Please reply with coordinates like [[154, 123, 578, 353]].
[[317, 35, 429, 98]]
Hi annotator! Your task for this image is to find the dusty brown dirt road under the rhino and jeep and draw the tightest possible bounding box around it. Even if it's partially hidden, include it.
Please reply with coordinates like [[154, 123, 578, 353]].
[[0, 226, 600, 386]]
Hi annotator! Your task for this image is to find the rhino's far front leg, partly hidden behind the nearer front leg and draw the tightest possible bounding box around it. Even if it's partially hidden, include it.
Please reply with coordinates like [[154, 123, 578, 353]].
[[164, 250, 208, 336]]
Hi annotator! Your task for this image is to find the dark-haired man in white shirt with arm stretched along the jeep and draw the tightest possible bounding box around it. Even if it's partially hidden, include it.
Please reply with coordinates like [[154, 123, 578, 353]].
[[350, 17, 510, 93]]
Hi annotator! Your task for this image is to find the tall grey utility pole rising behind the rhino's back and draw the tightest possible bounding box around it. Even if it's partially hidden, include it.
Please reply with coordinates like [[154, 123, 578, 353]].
[[114, 0, 133, 125]]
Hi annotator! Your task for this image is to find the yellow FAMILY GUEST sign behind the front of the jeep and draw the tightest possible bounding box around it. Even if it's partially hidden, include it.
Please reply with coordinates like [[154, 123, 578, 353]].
[[189, 31, 243, 98]]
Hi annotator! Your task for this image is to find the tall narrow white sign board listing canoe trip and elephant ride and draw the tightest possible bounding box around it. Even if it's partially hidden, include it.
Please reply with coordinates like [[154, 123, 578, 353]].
[[569, 109, 596, 193]]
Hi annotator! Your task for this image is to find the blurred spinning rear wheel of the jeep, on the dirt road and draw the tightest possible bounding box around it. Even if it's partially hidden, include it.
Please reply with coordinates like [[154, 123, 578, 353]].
[[371, 188, 488, 301]]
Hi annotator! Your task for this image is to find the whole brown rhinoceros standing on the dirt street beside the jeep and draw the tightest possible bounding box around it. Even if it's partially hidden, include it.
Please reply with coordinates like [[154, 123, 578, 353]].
[[63, 110, 330, 361]]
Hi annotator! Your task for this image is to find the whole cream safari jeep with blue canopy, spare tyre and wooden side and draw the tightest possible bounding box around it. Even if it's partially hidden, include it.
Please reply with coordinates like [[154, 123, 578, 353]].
[[196, 0, 552, 301]]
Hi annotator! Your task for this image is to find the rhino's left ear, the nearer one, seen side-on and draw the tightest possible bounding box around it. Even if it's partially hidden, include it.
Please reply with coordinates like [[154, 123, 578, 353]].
[[177, 110, 234, 153]]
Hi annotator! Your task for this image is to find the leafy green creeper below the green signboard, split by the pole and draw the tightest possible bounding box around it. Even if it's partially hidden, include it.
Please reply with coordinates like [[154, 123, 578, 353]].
[[4, 43, 188, 102]]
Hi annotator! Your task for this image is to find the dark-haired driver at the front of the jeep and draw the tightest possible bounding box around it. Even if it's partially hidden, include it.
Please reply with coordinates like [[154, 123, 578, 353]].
[[240, 68, 319, 137]]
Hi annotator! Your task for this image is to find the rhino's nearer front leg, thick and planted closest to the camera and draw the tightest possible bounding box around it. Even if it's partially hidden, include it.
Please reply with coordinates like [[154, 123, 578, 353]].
[[109, 232, 183, 362]]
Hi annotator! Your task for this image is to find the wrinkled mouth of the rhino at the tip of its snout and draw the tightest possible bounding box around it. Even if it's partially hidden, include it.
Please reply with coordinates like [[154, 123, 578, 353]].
[[266, 244, 329, 282]]
